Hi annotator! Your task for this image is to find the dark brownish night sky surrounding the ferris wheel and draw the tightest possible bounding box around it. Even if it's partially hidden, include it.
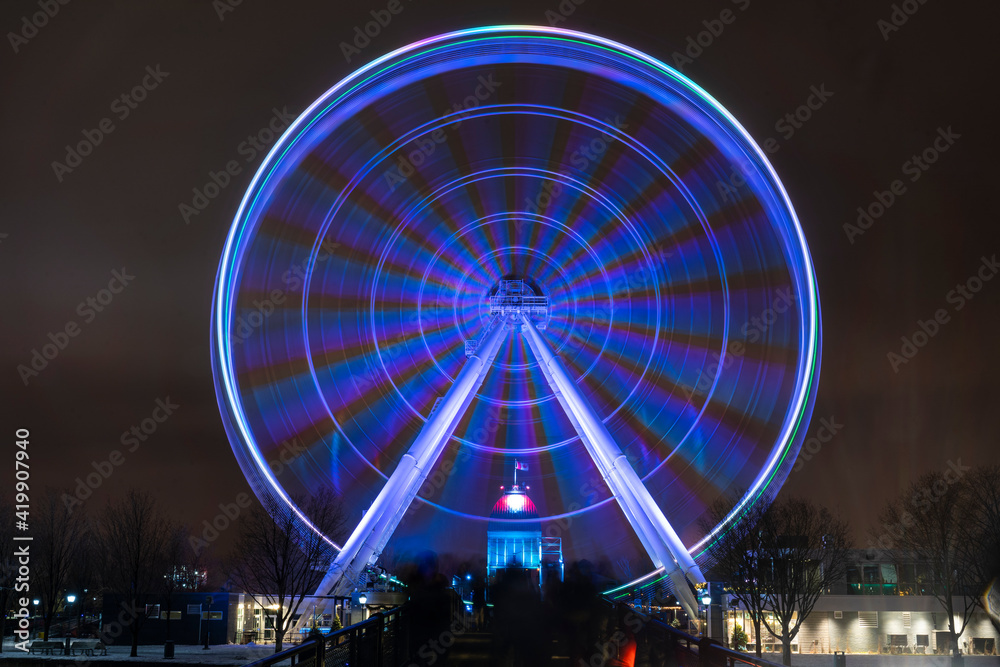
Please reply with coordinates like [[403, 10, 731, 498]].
[[0, 0, 1000, 564]]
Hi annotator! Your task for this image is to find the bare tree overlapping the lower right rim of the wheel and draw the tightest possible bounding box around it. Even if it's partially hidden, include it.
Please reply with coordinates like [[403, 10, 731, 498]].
[[701, 493, 767, 658]]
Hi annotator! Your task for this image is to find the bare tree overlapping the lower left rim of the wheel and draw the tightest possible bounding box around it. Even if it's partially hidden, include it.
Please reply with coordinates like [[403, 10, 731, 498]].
[[229, 492, 346, 653]]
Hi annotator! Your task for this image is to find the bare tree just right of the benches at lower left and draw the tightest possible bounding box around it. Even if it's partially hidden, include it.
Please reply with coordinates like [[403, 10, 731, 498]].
[[99, 489, 176, 658]]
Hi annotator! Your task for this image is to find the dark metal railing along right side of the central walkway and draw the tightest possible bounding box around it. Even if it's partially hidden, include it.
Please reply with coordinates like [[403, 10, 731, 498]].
[[609, 603, 781, 667]]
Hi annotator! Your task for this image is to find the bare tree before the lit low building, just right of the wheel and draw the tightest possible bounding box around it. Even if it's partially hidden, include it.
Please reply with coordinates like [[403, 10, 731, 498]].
[[758, 498, 851, 665]]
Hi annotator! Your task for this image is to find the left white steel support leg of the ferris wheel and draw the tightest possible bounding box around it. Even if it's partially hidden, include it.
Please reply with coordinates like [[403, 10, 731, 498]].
[[316, 317, 506, 595]]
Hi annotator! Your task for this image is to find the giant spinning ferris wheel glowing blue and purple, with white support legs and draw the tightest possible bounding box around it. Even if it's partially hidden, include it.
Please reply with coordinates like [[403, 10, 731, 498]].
[[212, 26, 820, 610]]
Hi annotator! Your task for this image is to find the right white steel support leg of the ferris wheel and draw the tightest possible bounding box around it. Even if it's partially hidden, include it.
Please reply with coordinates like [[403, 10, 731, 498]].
[[520, 314, 705, 618]]
